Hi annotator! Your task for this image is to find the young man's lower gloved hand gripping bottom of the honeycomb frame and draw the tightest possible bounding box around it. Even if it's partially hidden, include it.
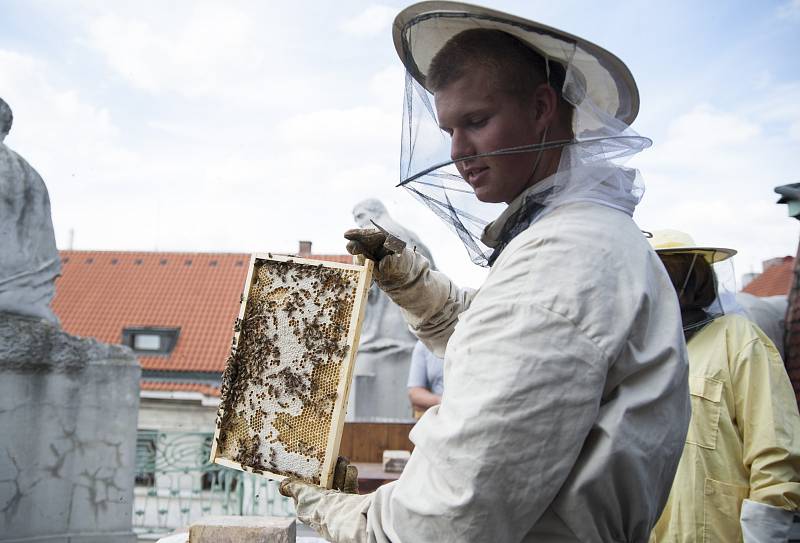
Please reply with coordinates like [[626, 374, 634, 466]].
[[280, 457, 371, 542]]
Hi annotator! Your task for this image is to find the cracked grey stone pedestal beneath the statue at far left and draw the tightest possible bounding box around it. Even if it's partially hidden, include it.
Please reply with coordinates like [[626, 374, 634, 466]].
[[0, 313, 141, 543]]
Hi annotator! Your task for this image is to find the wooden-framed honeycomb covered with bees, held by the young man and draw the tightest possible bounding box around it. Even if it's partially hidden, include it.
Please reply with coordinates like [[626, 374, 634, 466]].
[[214, 258, 365, 486]]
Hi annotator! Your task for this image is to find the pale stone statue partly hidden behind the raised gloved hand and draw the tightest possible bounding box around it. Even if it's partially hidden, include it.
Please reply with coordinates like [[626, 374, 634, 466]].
[[349, 198, 433, 420]]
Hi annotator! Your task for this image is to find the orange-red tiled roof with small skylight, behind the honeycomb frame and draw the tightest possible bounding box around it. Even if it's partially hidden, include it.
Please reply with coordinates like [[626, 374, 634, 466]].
[[52, 251, 352, 372]]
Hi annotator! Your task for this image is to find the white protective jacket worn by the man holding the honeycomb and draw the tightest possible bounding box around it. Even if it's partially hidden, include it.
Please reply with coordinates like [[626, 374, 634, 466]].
[[298, 198, 690, 543]]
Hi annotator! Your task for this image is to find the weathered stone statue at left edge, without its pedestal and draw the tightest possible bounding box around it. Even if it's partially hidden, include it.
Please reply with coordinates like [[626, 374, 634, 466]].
[[0, 98, 61, 323]]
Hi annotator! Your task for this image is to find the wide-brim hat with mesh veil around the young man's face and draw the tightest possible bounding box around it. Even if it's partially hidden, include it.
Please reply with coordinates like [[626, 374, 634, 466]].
[[395, 4, 651, 266]]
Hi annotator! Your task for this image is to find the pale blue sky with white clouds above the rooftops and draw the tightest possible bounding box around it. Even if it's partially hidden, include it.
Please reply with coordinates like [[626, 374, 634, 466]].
[[0, 0, 800, 287]]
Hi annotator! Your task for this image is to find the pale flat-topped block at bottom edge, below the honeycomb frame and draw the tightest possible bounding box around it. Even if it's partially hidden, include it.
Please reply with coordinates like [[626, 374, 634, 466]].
[[189, 517, 296, 543]]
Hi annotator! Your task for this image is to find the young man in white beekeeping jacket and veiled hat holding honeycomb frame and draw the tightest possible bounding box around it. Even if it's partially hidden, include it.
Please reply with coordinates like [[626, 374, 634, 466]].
[[282, 2, 689, 543]]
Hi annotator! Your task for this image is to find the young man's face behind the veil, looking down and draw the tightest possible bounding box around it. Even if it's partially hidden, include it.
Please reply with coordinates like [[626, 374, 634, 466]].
[[434, 65, 542, 203]]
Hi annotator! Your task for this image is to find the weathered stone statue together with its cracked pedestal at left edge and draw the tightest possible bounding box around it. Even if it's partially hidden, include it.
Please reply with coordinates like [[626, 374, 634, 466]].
[[0, 99, 141, 543]]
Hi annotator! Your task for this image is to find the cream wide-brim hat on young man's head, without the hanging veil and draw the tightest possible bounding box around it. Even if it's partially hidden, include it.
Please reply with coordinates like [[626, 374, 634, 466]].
[[392, 1, 639, 125]]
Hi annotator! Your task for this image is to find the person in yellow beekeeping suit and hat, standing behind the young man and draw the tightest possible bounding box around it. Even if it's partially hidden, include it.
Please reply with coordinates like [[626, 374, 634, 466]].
[[650, 230, 800, 543]]
